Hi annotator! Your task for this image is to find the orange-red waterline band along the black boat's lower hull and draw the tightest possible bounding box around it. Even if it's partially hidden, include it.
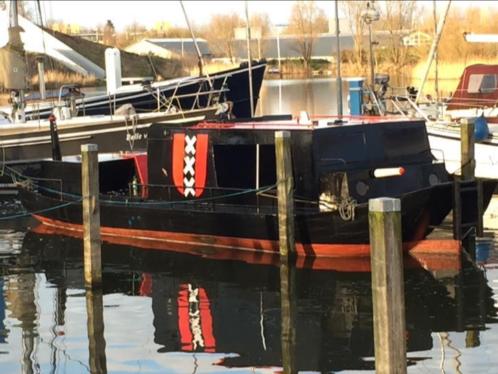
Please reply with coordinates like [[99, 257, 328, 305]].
[[30, 215, 460, 271]]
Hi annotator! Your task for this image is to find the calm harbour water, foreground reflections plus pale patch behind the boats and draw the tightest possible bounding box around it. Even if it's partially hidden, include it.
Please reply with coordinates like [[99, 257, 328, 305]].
[[0, 79, 498, 373]]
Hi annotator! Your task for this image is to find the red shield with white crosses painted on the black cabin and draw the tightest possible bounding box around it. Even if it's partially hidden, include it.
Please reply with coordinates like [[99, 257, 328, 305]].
[[172, 134, 208, 197]]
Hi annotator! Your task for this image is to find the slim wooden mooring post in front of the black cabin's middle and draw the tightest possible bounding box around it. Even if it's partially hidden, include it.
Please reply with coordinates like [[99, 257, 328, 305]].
[[275, 131, 295, 256]]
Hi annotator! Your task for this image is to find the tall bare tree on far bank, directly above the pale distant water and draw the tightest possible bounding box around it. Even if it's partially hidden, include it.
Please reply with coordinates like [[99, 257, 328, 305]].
[[288, 1, 328, 73]]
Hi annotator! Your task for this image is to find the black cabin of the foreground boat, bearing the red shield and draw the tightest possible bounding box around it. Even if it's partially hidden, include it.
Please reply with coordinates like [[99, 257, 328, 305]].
[[148, 117, 448, 209]]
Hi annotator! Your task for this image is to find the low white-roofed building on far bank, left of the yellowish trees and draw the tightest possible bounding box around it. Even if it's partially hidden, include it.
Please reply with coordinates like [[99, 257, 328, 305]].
[[125, 38, 212, 58]]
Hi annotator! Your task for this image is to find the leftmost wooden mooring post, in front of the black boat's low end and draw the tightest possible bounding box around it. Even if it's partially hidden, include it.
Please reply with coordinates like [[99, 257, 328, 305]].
[[81, 144, 102, 288]]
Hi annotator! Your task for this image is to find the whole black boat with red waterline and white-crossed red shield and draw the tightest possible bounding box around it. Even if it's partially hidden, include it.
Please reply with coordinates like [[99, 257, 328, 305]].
[[16, 117, 494, 257]]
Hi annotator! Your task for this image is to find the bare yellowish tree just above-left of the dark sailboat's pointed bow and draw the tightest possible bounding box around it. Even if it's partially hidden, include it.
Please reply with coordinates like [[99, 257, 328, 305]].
[[204, 13, 244, 62]]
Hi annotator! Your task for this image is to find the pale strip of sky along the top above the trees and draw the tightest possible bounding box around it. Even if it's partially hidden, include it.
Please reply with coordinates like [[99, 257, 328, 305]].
[[41, 0, 498, 31]]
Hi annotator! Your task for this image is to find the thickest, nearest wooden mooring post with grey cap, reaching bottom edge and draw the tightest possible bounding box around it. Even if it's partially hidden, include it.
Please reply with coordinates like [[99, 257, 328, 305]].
[[368, 198, 406, 374]]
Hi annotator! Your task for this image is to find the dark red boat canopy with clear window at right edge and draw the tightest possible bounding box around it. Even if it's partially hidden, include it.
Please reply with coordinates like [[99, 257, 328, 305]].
[[448, 64, 498, 110]]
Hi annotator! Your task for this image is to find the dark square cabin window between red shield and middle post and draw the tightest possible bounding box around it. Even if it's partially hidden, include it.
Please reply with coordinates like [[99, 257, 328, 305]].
[[213, 144, 277, 189]]
